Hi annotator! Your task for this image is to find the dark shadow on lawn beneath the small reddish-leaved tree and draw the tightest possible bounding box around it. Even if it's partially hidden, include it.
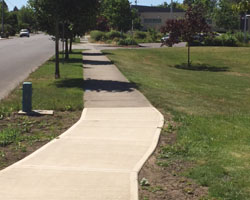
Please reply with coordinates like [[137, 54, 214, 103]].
[[174, 63, 229, 72]]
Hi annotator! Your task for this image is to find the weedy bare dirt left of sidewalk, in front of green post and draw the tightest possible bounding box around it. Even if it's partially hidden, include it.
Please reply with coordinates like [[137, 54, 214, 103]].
[[0, 111, 81, 170]]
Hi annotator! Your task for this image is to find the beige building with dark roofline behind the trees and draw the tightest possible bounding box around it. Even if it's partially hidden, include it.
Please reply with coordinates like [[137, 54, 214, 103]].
[[132, 6, 185, 30]]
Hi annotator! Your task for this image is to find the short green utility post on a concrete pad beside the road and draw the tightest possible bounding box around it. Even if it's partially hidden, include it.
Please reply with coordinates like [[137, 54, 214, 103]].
[[22, 82, 32, 113]]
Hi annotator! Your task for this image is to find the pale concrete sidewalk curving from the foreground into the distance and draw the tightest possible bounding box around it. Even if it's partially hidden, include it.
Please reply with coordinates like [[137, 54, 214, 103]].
[[0, 50, 164, 200]]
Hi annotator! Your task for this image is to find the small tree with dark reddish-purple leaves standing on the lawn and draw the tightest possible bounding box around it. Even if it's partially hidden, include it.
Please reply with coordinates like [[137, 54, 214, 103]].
[[161, 5, 210, 67]]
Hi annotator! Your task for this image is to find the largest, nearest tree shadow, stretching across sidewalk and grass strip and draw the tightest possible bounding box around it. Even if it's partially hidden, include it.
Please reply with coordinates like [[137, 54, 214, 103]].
[[55, 78, 137, 92]]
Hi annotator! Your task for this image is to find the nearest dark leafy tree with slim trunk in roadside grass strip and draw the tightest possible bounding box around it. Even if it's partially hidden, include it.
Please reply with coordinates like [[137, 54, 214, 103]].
[[29, 0, 99, 78]]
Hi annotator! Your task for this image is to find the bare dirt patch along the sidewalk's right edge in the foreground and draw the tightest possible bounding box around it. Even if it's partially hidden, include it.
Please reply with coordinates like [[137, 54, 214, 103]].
[[139, 111, 208, 200]]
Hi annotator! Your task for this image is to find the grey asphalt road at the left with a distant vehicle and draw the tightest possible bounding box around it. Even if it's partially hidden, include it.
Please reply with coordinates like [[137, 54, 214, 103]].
[[0, 34, 54, 99]]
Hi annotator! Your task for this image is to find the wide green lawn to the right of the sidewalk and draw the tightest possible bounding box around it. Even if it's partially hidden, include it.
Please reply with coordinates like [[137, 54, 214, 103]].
[[105, 47, 250, 200]]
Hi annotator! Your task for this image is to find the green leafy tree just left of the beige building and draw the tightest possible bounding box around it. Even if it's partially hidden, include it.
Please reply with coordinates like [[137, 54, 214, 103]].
[[101, 0, 132, 32]]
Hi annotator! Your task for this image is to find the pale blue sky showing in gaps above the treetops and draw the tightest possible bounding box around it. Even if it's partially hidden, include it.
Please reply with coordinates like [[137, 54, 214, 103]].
[[5, 0, 178, 10]]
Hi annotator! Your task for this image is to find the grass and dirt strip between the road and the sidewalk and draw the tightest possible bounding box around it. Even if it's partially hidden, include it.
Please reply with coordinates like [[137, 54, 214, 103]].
[[0, 50, 83, 169]]
